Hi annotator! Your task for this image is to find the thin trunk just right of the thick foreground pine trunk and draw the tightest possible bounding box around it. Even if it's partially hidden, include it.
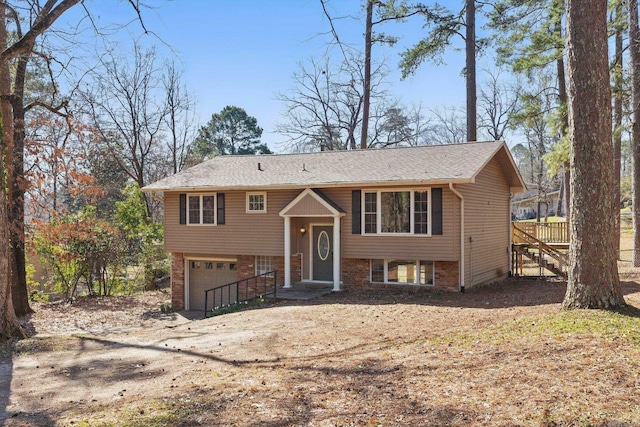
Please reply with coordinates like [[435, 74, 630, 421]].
[[613, 3, 624, 259]]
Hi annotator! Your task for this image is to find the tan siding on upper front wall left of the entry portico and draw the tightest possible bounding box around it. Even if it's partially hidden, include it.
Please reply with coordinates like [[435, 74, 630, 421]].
[[164, 190, 300, 256]]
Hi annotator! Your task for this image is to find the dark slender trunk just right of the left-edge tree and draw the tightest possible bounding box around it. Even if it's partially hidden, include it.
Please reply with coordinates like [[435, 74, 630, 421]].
[[9, 56, 33, 317]]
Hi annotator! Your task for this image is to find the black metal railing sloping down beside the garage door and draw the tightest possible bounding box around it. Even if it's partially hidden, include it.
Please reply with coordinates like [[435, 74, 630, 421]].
[[204, 270, 278, 318]]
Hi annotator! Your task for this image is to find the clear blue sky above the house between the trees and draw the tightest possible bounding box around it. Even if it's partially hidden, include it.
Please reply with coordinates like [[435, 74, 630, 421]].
[[61, 0, 480, 152]]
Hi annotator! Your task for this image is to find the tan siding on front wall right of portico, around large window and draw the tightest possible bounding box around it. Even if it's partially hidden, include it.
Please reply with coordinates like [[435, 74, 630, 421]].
[[322, 186, 460, 261]]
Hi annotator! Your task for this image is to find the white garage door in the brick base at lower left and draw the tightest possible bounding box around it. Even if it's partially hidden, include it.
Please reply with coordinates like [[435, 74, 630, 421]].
[[185, 259, 238, 310]]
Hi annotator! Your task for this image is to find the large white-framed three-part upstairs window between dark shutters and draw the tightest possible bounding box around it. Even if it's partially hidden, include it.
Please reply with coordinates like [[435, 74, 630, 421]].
[[362, 188, 431, 236]]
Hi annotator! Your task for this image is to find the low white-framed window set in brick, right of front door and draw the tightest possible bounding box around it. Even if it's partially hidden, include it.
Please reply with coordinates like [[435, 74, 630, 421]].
[[371, 259, 434, 286]]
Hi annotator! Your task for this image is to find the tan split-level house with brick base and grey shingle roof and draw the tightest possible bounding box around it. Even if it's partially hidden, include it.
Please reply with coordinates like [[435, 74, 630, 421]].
[[143, 141, 525, 310]]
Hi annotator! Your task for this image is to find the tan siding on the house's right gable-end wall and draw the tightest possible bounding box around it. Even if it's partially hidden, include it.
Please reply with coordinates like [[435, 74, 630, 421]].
[[458, 159, 510, 286]]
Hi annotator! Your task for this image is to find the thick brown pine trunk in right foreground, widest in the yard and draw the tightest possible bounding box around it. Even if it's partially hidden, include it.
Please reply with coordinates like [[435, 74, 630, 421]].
[[562, 0, 624, 309]]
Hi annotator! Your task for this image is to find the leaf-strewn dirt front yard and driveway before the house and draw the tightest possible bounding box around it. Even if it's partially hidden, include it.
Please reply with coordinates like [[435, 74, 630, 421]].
[[0, 281, 640, 426]]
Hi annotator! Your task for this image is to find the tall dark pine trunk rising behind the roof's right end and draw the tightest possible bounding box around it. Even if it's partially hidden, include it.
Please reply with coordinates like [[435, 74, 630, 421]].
[[465, 0, 478, 141]]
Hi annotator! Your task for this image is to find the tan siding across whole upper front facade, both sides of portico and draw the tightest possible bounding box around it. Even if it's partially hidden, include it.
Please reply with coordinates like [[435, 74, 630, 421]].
[[165, 186, 460, 261]]
